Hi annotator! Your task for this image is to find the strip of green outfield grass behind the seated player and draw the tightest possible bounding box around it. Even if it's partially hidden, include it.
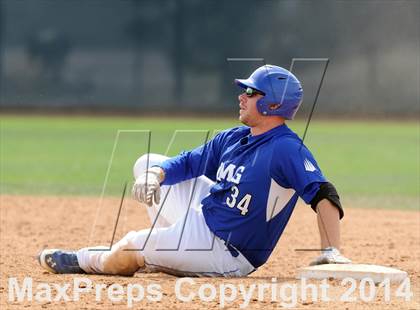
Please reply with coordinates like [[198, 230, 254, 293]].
[[0, 116, 420, 209]]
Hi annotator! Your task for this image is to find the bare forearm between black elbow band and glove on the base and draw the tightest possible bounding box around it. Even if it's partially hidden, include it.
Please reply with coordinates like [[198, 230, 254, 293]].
[[317, 199, 340, 249]]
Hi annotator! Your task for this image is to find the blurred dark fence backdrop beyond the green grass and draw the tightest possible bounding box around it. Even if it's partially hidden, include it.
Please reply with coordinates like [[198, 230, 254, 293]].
[[0, 0, 420, 117]]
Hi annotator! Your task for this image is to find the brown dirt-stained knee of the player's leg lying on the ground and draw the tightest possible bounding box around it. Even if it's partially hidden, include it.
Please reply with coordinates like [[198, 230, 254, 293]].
[[102, 232, 144, 276]]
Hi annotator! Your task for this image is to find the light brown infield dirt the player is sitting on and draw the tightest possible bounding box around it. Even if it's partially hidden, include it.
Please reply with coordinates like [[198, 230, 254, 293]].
[[0, 195, 420, 309]]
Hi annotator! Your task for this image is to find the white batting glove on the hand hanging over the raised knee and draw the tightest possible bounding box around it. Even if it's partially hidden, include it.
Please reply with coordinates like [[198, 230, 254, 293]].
[[131, 167, 163, 207]]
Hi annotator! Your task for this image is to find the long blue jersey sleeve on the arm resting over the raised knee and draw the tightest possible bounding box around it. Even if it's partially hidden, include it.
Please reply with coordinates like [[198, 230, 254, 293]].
[[159, 132, 230, 185]]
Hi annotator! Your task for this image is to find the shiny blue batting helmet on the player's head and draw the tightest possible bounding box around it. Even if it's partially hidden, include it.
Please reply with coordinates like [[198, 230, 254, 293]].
[[235, 65, 303, 119]]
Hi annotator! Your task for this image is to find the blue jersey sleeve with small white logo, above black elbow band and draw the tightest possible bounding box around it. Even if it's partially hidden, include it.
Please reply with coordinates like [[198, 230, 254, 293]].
[[271, 138, 327, 204]]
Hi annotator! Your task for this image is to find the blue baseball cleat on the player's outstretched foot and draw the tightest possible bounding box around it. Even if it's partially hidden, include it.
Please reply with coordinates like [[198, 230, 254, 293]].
[[38, 249, 85, 273]]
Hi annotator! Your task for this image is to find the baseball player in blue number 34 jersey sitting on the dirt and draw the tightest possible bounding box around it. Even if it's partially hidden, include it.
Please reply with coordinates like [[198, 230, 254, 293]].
[[39, 65, 350, 277]]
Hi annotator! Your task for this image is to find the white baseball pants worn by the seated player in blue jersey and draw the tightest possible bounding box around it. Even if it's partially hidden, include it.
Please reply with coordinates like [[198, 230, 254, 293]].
[[77, 154, 255, 277]]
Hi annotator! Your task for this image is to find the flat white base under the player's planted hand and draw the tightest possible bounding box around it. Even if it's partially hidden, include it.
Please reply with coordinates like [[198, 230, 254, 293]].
[[297, 264, 407, 283]]
